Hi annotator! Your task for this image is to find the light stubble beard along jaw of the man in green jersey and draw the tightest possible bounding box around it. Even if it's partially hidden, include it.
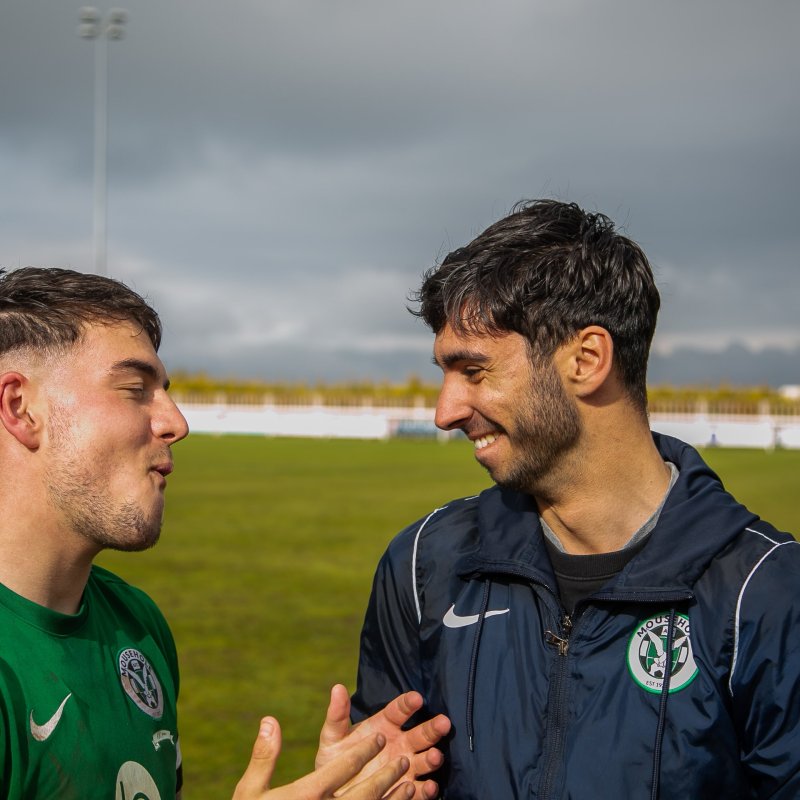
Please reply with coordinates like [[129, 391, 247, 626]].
[[46, 414, 163, 552]]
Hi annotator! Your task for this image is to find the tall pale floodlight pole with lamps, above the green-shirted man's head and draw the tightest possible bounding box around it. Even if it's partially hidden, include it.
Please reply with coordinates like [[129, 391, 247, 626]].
[[78, 6, 128, 275]]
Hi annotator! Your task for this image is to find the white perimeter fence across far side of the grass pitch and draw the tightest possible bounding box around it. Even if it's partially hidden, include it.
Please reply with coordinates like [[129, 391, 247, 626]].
[[178, 401, 800, 449]]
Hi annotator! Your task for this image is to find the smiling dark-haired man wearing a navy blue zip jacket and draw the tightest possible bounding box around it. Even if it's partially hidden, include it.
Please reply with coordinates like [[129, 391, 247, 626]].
[[353, 200, 800, 800]]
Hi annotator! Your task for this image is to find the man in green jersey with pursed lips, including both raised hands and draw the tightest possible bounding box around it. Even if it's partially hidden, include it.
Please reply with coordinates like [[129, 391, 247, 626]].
[[0, 268, 449, 800]]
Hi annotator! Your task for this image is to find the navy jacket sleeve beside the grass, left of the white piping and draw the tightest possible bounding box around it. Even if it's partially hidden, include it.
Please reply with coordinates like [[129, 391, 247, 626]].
[[351, 530, 425, 724]]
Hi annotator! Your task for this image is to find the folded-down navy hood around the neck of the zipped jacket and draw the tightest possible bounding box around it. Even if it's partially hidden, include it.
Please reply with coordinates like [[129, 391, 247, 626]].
[[458, 433, 758, 600]]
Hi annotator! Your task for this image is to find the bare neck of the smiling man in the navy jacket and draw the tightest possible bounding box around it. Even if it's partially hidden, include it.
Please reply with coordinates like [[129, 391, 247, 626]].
[[533, 410, 670, 555]]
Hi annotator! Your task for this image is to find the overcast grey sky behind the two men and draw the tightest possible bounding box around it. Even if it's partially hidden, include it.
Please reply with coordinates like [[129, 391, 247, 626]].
[[0, 0, 800, 385]]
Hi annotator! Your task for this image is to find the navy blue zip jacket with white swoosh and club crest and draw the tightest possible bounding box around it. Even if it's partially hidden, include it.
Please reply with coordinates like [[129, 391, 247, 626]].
[[353, 435, 800, 800]]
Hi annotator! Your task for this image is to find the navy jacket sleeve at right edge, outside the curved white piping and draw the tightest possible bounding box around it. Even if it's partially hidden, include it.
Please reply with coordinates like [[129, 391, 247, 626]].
[[730, 541, 800, 800]]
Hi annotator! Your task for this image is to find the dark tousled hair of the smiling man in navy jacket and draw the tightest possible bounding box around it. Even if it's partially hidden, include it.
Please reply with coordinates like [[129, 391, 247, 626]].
[[410, 200, 660, 409]]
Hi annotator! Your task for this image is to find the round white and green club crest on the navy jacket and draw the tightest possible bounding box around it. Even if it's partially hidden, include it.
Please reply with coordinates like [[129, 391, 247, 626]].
[[628, 614, 698, 694]]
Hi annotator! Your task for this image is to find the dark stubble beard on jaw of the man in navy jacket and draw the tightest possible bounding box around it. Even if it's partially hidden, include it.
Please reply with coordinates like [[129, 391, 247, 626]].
[[492, 363, 583, 495]]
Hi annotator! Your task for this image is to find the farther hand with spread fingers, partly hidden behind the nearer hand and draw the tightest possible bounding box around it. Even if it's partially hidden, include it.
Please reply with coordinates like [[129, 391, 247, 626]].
[[316, 684, 450, 800]]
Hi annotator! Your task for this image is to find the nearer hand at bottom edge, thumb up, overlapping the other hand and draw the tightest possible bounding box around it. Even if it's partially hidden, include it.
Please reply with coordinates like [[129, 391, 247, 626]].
[[233, 717, 415, 800]]
